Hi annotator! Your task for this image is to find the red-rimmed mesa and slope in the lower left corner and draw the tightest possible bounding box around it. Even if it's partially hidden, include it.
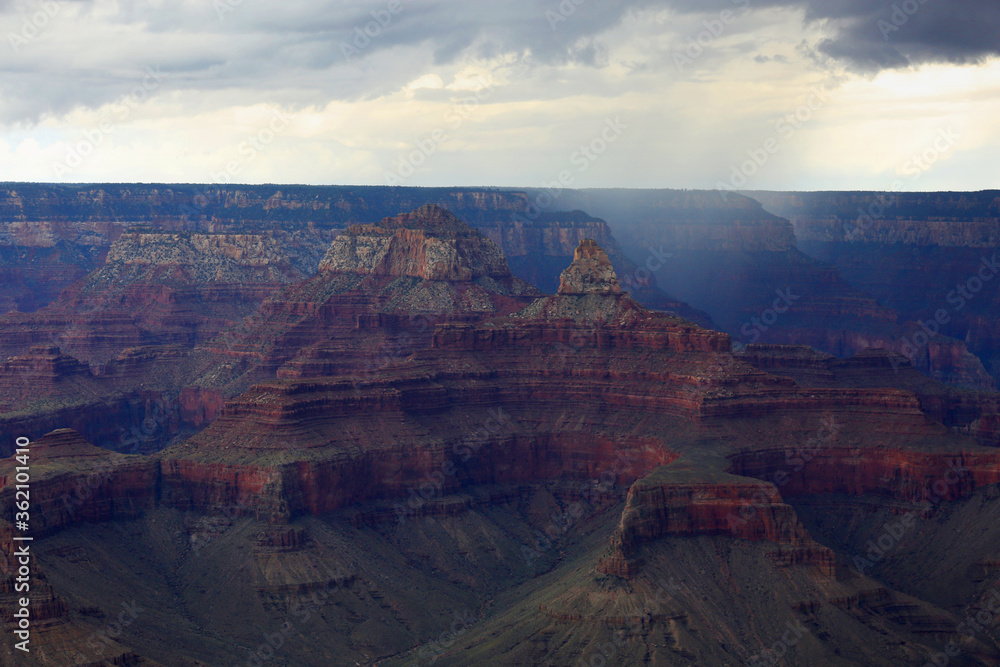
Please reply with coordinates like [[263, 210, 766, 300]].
[[0, 429, 160, 667]]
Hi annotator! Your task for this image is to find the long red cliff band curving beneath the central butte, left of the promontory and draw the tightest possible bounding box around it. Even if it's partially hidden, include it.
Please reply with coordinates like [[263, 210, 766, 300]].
[[162, 432, 677, 521]]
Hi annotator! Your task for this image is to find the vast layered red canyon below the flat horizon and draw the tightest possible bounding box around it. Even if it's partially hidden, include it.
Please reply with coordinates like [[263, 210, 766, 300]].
[[0, 186, 1000, 666]]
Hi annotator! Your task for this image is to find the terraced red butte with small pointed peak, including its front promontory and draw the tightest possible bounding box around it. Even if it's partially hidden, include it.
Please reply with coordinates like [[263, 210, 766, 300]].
[[145, 242, 1000, 664]]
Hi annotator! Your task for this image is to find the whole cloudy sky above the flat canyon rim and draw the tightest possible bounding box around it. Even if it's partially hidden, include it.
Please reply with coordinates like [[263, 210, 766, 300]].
[[0, 0, 1000, 190]]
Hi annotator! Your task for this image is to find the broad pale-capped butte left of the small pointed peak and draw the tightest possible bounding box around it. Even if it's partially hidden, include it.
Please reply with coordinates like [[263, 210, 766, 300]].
[[206, 205, 539, 392]]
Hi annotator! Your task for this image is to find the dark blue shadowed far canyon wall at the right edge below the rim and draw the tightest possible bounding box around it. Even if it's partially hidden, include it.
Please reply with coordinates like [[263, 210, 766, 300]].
[[752, 191, 1000, 388]]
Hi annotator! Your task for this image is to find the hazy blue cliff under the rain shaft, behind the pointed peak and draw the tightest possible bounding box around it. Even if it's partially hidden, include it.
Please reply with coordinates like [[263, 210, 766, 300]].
[[544, 190, 896, 370]]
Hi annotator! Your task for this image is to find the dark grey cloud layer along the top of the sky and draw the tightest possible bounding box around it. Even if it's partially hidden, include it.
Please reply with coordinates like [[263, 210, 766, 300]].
[[0, 0, 1000, 123]]
